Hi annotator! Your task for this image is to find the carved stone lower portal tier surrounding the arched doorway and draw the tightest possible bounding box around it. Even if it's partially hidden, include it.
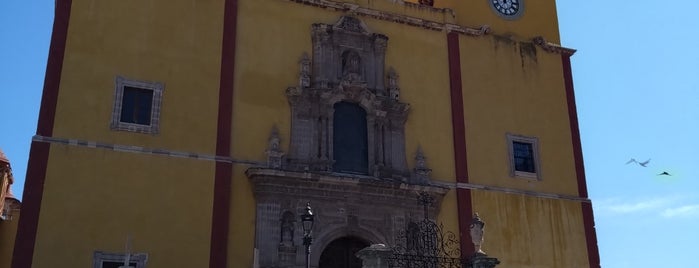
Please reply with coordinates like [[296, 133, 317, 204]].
[[246, 168, 449, 268]]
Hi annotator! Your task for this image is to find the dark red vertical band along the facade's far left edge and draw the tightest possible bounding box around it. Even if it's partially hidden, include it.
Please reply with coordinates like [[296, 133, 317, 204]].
[[12, 0, 73, 268]]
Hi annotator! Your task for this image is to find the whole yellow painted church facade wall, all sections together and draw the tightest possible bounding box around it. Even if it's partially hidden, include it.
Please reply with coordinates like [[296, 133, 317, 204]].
[[34, 0, 586, 267]]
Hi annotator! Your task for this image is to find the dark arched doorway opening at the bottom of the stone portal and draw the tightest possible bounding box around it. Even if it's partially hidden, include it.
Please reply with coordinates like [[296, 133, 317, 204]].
[[318, 236, 369, 268]]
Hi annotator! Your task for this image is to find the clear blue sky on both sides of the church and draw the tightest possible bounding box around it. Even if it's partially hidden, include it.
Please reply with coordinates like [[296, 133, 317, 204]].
[[0, 0, 699, 268]]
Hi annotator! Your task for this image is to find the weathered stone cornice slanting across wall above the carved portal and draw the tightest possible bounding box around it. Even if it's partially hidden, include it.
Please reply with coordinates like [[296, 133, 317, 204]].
[[285, 0, 490, 36]]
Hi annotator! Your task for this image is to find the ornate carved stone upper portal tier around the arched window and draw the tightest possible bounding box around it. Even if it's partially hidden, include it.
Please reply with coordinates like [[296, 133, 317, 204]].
[[283, 16, 410, 181]]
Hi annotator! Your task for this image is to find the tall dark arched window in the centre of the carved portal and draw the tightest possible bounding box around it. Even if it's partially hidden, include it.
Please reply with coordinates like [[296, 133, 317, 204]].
[[333, 102, 369, 174]]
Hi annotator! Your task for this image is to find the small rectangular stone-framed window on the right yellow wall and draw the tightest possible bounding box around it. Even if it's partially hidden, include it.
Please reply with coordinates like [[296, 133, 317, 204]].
[[507, 133, 541, 180]]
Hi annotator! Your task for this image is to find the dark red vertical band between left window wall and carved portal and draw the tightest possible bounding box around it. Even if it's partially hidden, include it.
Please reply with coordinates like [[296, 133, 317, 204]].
[[209, 0, 238, 268]]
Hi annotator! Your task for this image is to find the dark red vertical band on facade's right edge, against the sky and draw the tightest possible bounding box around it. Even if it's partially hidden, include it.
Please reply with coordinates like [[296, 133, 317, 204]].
[[561, 55, 600, 268]]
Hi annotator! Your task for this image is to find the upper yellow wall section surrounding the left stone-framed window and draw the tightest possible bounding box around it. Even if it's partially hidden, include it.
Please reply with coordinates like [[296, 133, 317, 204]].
[[54, 0, 223, 154]]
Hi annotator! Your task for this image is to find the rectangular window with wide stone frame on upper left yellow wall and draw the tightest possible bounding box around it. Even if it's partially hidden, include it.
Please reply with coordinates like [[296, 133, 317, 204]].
[[111, 77, 163, 134]]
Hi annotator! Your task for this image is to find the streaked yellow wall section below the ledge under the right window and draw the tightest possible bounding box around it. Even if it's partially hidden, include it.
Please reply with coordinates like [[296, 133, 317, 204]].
[[473, 191, 590, 268]]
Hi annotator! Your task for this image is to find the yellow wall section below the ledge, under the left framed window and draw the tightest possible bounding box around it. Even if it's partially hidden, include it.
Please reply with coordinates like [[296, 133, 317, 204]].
[[33, 144, 214, 268]]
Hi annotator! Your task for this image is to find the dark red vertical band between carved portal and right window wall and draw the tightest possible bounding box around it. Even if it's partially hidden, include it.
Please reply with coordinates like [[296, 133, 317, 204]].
[[447, 32, 475, 256]]
